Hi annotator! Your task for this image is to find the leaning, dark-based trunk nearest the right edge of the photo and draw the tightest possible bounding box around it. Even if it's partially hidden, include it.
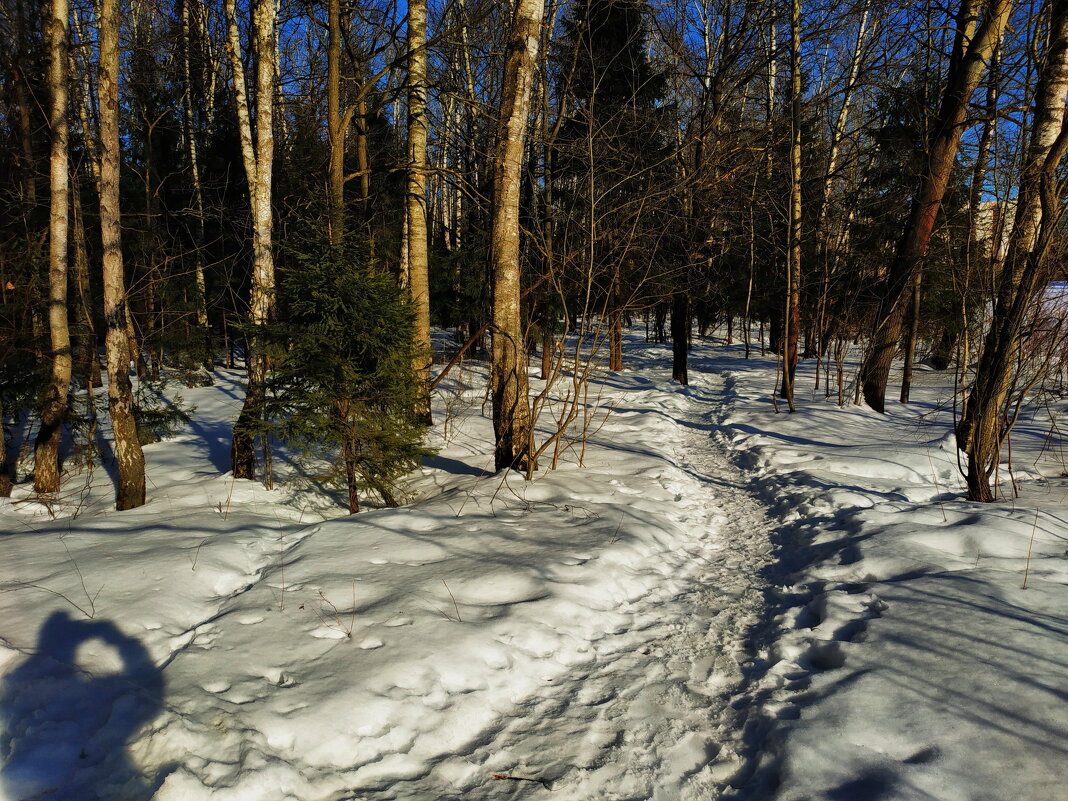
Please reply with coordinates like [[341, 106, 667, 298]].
[[957, 0, 1068, 502]]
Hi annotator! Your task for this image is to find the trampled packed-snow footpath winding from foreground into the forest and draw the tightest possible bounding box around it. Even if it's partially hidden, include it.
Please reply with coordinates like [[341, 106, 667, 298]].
[[371, 376, 772, 801]]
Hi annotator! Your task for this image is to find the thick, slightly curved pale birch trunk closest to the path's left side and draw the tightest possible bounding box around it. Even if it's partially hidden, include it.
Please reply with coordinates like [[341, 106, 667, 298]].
[[491, 0, 545, 476]]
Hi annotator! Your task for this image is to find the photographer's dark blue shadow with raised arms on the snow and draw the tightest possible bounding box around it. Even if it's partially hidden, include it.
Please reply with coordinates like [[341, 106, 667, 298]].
[[0, 612, 163, 801]]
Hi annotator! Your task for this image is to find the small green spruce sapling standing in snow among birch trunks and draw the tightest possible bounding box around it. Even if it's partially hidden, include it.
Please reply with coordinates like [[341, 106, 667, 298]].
[[267, 240, 429, 513]]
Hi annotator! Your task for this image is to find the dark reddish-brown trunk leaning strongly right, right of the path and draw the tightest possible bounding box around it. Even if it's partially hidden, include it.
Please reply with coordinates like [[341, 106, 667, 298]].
[[860, 0, 1012, 412]]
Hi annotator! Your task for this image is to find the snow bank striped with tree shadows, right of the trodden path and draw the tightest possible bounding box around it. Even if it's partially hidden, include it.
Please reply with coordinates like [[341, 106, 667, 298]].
[[716, 348, 1068, 801]]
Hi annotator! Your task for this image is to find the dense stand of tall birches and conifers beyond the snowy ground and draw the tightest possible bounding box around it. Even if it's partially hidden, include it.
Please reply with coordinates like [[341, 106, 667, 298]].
[[0, 0, 1068, 511]]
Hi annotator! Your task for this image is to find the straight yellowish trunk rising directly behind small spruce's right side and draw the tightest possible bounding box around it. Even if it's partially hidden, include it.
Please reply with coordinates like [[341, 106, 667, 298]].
[[405, 0, 431, 424]]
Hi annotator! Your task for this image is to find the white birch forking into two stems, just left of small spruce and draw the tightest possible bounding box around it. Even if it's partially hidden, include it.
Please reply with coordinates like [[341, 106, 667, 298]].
[[225, 0, 278, 487]]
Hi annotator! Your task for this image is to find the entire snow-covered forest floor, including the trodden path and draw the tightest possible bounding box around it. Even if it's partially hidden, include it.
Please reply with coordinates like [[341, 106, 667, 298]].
[[0, 332, 1068, 801]]
